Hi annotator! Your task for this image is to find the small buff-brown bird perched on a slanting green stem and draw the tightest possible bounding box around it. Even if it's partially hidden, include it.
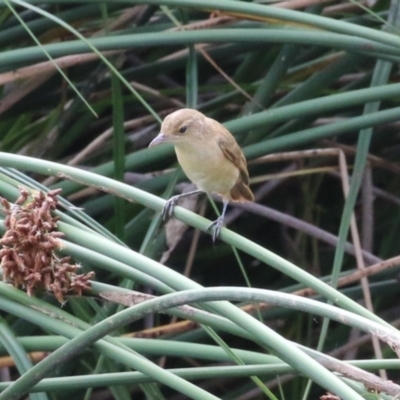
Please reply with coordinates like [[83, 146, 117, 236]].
[[149, 108, 254, 241]]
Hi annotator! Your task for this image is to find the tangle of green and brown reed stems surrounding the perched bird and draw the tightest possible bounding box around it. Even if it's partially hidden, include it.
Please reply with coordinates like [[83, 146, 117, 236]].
[[0, 0, 400, 400]]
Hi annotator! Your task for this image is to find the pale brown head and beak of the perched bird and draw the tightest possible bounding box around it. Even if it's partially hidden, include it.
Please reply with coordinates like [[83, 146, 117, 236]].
[[149, 108, 205, 147]]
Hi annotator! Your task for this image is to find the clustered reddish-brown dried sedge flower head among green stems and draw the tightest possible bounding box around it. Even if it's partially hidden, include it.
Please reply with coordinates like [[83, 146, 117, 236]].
[[0, 188, 94, 303]]
